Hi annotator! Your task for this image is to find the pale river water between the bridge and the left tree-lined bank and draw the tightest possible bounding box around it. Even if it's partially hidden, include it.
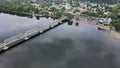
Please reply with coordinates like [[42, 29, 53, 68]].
[[0, 13, 54, 42]]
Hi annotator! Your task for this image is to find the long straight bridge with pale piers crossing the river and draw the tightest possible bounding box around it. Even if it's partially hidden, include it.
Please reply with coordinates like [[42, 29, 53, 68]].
[[0, 17, 67, 51]]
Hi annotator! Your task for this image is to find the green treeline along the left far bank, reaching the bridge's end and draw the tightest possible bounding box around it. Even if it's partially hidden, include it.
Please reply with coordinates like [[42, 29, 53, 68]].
[[0, 2, 73, 19]]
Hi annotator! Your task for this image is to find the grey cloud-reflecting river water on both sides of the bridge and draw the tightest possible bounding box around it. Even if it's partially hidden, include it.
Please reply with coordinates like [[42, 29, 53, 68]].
[[0, 13, 120, 68]]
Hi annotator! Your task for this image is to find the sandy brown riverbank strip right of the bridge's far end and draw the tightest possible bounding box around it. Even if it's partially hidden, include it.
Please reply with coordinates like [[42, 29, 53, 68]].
[[73, 19, 120, 40]]
